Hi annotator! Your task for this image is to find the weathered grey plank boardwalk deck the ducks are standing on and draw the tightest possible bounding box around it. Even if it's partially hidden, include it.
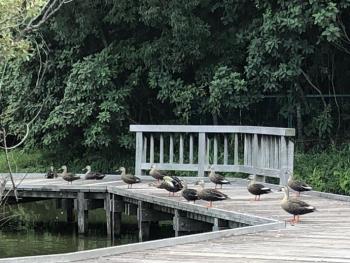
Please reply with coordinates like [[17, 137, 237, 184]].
[[0, 176, 350, 263]]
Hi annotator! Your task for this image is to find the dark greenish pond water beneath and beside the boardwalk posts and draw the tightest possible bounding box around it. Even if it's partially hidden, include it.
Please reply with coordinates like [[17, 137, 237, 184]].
[[0, 200, 174, 258]]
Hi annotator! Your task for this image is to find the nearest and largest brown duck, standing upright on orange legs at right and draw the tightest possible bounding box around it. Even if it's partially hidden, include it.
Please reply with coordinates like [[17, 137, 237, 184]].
[[281, 186, 316, 224]]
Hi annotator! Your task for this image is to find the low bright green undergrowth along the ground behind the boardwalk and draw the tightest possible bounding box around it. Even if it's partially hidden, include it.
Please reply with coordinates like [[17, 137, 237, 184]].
[[0, 144, 350, 195]]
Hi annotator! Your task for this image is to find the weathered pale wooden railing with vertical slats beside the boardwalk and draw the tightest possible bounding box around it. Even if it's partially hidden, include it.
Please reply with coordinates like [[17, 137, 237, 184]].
[[130, 125, 295, 184]]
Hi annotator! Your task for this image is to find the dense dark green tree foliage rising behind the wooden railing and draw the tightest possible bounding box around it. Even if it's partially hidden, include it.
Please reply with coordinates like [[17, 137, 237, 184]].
[[0, 0, 350, 154]]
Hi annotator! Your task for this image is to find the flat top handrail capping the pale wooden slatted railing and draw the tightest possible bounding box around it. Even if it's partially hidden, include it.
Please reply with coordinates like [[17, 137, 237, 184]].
[[130, 125, 295, 136]]
